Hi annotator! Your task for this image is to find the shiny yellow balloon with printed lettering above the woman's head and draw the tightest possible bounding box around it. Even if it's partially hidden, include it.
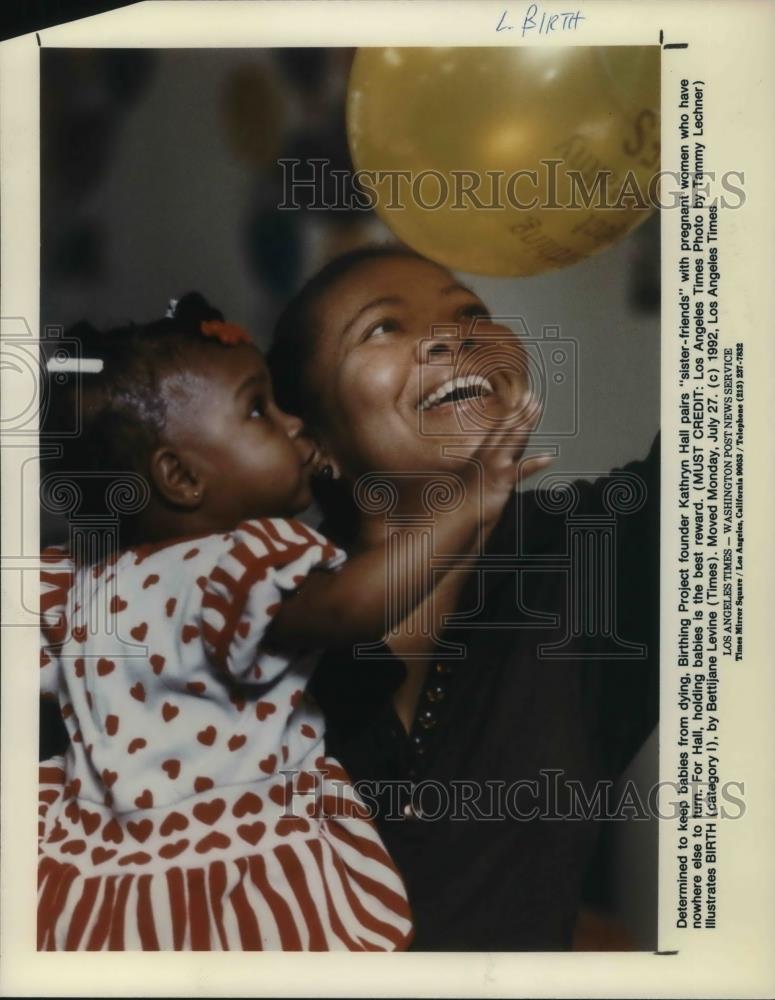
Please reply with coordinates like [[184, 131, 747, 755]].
[[347, 46, 660, 275]]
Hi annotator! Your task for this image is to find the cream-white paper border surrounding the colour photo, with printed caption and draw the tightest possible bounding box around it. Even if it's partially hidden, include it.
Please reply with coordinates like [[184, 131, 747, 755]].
[[0, 0, 775, 997]]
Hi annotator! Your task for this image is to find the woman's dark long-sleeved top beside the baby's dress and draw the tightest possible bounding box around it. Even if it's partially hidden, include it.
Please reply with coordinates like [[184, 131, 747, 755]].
[[312, 434, 659, 951]]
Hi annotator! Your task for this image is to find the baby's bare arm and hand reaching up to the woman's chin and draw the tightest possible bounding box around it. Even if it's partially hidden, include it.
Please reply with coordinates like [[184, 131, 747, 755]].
[[266, 418, 548, 648]]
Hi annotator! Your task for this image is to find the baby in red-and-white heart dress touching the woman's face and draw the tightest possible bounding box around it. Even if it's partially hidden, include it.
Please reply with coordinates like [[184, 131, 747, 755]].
[[38, 293, 532, 951]]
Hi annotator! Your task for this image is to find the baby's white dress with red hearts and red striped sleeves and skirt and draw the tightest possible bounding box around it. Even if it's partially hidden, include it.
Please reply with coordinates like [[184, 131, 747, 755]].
[[38, 518, 411, 951]]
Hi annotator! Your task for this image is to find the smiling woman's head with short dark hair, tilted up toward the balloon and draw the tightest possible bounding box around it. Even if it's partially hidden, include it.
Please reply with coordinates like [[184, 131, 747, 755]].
[[268, 248, 531, 481]]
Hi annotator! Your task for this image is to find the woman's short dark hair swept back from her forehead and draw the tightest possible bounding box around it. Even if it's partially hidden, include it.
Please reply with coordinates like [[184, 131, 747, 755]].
[[266, 243, 426, 427]]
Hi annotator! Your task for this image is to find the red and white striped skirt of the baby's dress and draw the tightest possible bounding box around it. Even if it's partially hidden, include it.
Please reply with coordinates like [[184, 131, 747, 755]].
[[38, 758, 412, 951]]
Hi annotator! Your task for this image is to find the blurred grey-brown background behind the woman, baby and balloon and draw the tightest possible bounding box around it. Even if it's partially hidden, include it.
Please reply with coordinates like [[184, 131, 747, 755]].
[[41, 48, 660, 950]]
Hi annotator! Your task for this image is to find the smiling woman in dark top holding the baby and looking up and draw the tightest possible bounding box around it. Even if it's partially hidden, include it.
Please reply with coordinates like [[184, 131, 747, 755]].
[[269, 246, 659, 951]]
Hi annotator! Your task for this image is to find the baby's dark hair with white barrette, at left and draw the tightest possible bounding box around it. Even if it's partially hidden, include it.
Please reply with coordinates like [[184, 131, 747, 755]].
[[41, 292, 223, 542]]
